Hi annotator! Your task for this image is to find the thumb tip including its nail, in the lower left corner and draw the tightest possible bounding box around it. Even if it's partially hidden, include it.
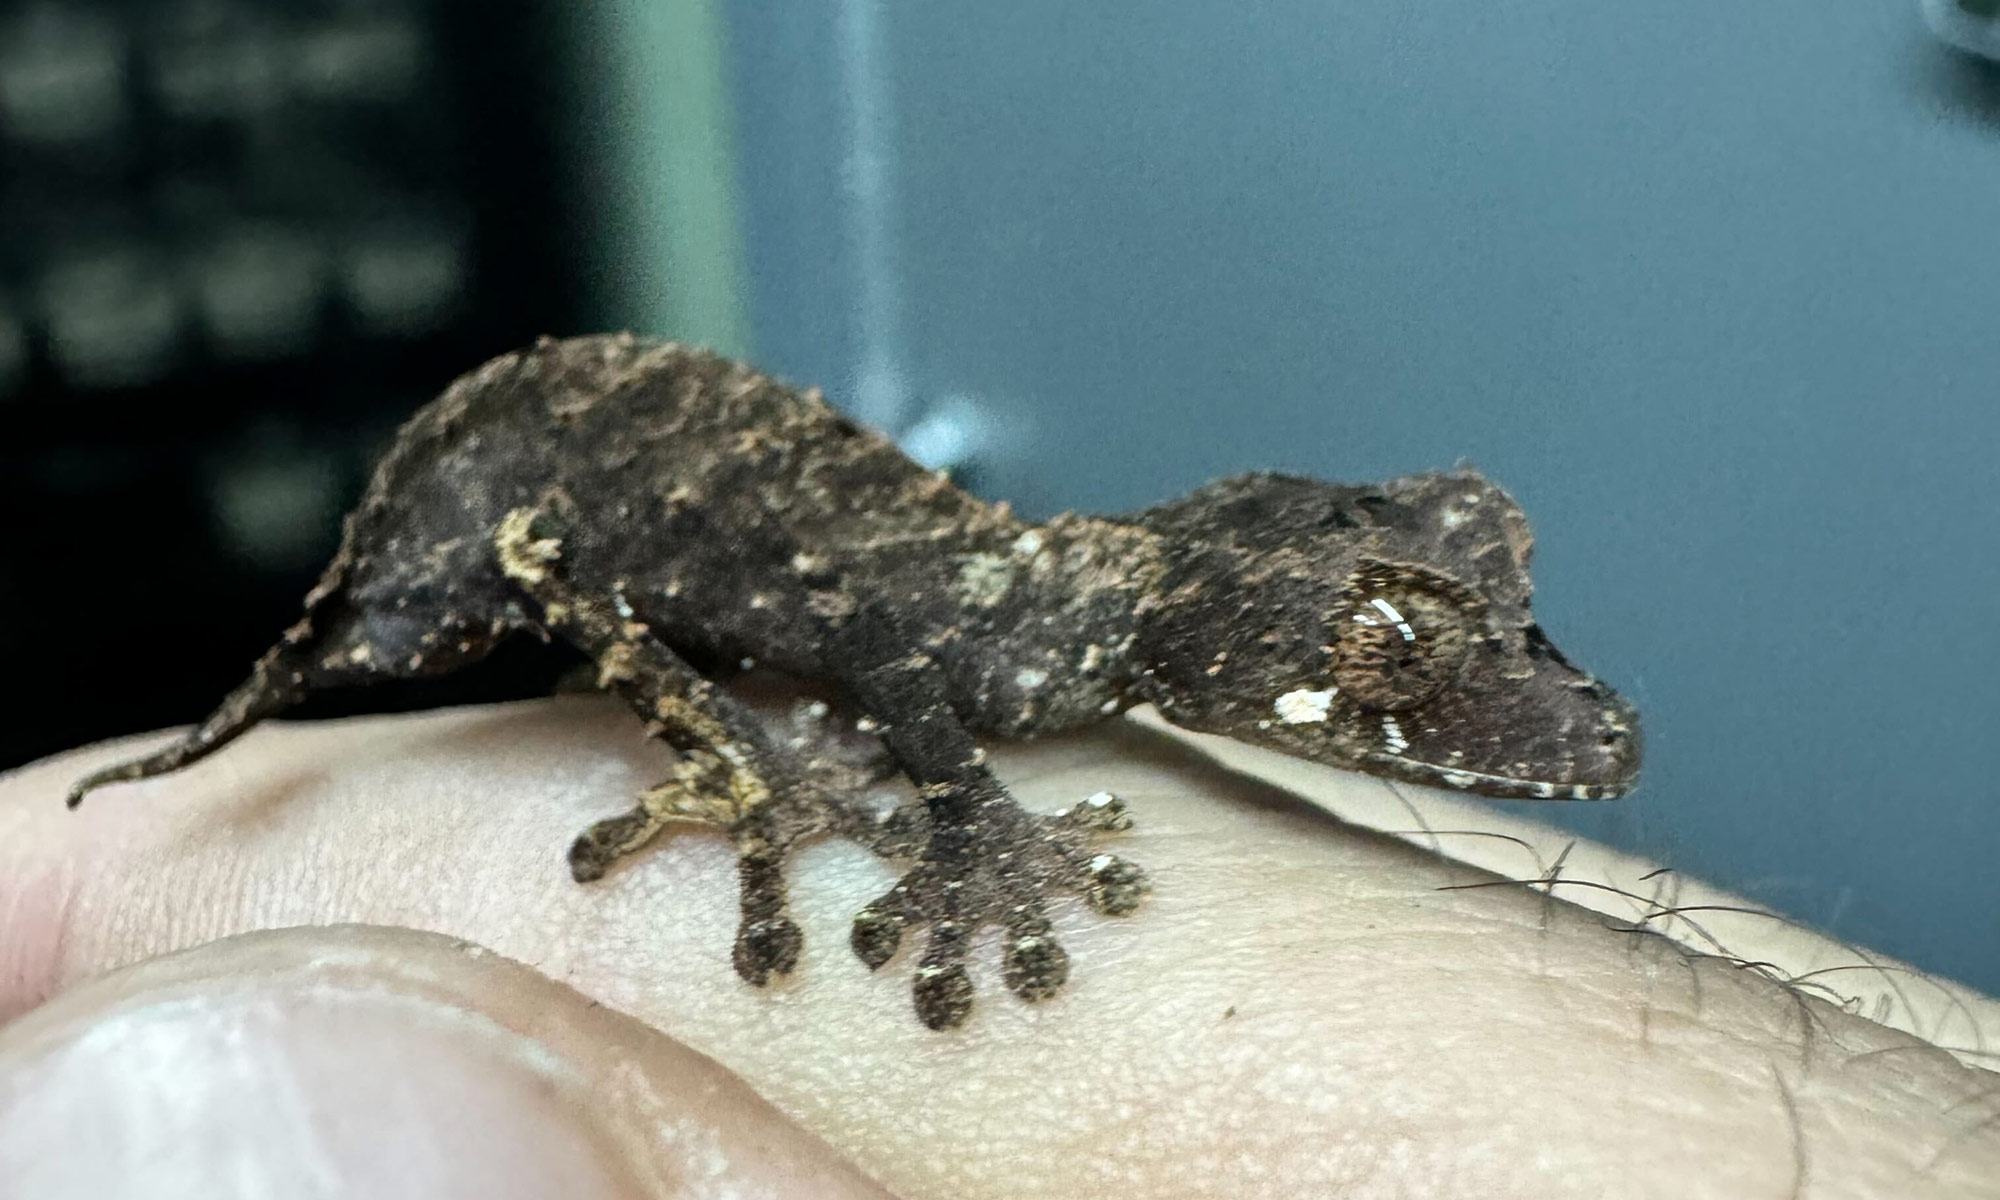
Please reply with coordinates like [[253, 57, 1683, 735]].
[[0, 926, 882, 1200]]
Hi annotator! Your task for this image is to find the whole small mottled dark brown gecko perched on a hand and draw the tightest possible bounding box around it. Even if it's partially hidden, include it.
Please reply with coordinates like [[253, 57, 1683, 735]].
[[70, 336, 1638, 1028]]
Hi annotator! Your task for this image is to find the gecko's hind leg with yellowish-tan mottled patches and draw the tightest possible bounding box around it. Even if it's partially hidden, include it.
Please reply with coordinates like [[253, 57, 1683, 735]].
[[494, 508, 866, 986]]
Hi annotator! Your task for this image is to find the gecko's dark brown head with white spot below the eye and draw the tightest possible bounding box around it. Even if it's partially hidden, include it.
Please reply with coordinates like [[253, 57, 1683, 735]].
[[1140, 470, 1640, 800]]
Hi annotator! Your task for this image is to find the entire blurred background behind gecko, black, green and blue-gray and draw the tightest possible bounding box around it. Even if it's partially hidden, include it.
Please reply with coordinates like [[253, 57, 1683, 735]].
[[0, 0, 2000, 1004]]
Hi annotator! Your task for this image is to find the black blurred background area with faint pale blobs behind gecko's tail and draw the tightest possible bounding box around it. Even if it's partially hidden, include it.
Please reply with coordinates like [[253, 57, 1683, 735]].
[[0, 0, 582, 766]]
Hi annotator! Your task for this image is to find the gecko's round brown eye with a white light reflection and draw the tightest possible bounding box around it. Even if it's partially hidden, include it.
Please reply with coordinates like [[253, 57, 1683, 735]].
[[1334, 570, 1472, 712]]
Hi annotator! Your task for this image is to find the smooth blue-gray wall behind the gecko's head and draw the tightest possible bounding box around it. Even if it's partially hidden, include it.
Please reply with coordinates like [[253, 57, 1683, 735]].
[[712, 0, 2000, 990]]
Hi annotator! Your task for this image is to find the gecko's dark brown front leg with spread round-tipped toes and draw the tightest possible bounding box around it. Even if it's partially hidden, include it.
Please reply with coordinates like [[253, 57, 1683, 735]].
[[830, 604, 1146, 1030]]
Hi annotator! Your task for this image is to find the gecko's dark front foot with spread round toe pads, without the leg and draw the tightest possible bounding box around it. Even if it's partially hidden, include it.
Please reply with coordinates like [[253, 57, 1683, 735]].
[[850, 786, 1146, 1030]]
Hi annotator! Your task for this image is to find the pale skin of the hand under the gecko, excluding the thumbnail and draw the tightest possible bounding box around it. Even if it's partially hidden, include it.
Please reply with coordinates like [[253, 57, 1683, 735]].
[[0, 698, 2000, 1200]]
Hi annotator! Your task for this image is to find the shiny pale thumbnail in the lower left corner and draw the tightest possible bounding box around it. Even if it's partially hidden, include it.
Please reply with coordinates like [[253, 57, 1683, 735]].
[[0, 978, 658, 1200]]
